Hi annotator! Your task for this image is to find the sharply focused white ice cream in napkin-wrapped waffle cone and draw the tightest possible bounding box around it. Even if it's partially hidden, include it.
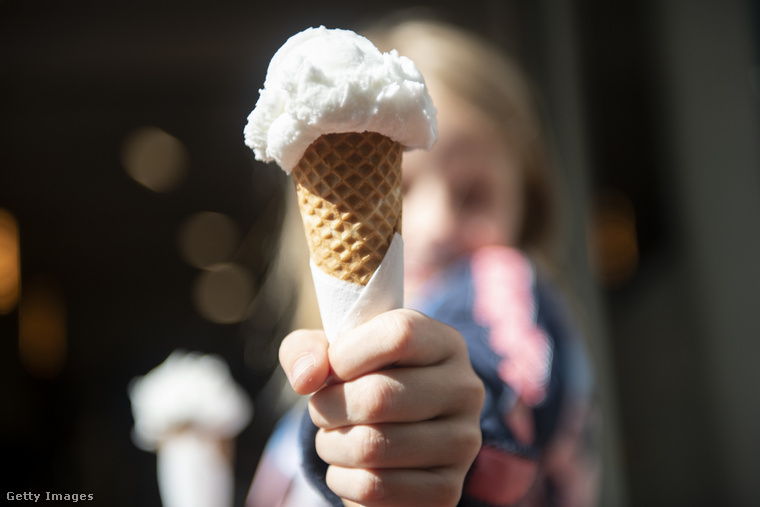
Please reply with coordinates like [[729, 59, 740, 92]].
[[244, 26, 438, 341]]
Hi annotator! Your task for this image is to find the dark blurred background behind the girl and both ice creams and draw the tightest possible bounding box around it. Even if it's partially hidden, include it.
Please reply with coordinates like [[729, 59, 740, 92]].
[[0, 0, 760, 507]]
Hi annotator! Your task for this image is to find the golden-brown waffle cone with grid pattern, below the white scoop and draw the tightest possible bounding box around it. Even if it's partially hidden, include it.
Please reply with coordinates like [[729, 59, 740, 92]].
[[293, 132, 403, 285]]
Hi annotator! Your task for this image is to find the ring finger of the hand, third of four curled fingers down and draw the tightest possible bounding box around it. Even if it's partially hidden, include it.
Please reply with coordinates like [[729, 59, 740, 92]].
[[315, 419, 482, 469]]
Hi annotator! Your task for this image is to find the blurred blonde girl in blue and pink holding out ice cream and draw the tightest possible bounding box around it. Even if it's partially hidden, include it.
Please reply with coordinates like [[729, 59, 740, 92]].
[[249, 13, 597, 506]]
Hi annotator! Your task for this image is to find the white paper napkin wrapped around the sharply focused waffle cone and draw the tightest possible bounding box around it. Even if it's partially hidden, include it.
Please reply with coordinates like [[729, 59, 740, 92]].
[[311, 234, 404, 342]]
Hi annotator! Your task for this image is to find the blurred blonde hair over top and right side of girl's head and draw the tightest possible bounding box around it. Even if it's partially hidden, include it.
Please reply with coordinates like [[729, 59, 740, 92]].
[[362, 19, 556, 261]]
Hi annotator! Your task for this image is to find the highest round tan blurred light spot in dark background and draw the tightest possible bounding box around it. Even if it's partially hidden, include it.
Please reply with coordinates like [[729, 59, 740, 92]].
[[121, 127, 188, 192]]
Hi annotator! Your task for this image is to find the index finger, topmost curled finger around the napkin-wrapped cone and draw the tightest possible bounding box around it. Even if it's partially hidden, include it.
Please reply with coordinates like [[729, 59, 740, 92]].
[[329, 310, 464, 380]]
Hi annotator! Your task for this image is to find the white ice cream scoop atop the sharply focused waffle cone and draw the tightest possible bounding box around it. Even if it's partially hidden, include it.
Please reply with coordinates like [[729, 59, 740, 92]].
[[244, 26, 437, 173]]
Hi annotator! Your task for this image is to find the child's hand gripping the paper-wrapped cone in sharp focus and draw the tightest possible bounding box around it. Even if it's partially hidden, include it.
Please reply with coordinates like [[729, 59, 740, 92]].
[[280, 310, 484, 507]]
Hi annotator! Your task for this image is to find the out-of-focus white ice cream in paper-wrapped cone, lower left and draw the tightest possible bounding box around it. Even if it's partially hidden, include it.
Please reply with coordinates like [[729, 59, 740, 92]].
[[129, 351, 253, 507]]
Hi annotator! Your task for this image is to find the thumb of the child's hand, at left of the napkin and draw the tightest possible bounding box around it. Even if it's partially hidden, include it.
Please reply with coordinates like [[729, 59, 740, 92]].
[[280, 330, 330, 394]]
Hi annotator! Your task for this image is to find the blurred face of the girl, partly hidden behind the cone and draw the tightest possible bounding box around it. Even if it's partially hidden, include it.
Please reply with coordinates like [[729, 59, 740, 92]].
[[402, 88, 523, 297]]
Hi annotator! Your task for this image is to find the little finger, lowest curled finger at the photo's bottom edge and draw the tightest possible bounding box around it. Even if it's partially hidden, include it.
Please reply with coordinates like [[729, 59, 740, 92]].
[[327, 466, 462, 507]]
